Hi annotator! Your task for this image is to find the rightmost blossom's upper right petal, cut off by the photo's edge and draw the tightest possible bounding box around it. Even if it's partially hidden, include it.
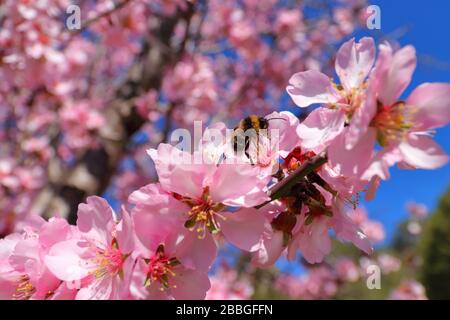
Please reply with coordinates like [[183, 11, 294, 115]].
[[406, 83, 450, 130]]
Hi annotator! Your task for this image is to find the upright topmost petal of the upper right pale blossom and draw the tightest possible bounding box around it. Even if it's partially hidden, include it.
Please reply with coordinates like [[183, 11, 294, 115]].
[[335, 37, 375, 91]]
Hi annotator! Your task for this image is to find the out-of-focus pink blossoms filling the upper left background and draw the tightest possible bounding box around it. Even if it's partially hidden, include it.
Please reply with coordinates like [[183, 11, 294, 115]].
[[0, 0, 365, 235]]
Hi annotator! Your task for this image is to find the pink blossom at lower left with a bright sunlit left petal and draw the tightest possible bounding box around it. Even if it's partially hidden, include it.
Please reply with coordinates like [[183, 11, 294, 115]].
[[45, 197, 134, 300]]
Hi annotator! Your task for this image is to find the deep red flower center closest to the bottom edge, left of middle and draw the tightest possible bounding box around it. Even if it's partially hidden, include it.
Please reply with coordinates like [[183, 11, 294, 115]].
[[144, 244, 180, 291]]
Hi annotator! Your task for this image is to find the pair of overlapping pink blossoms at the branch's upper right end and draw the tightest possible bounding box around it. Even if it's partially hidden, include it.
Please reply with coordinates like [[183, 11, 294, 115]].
[[287, 38, 450, 197]]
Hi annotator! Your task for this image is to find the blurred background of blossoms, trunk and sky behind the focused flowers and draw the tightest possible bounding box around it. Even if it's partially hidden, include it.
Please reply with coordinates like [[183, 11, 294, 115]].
[[0, 0, 450, 299]]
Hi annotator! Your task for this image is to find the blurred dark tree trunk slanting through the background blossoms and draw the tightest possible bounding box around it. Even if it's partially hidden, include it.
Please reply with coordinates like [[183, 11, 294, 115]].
[[41, 5, 194, 223]]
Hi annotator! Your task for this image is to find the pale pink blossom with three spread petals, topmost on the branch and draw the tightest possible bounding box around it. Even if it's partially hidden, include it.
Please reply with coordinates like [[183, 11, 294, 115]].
[[286, 38, 375, 149]]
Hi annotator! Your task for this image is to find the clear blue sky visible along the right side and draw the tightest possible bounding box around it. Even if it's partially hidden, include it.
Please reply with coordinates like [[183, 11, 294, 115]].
[[357, 0, 450, 241]]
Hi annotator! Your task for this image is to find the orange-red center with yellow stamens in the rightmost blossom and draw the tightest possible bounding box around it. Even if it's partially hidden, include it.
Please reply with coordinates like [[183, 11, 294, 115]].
[[371, 101, 415, 147]]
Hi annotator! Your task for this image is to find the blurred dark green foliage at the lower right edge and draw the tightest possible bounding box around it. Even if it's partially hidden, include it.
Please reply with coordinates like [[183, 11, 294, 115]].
[[420, 187, 450, 299]]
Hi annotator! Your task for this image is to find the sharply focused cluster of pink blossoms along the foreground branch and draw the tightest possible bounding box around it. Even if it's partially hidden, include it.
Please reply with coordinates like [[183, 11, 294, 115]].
[[0, 38, 450, 299]]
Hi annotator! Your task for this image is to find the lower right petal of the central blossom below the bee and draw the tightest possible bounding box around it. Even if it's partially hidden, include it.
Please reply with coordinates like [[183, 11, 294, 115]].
[[220, 208, 265, 252]]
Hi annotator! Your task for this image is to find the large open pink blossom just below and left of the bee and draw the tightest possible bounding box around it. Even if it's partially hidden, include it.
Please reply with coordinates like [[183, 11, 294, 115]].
[[141, 144, 267, 255]]
